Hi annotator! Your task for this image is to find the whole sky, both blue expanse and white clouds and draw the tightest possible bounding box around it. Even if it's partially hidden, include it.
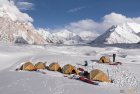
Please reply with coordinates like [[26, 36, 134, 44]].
[[0, 0, 140, 33]]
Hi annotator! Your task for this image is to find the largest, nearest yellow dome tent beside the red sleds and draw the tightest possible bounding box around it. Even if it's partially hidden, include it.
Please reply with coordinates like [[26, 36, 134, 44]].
[[88, 69, 111, 82]]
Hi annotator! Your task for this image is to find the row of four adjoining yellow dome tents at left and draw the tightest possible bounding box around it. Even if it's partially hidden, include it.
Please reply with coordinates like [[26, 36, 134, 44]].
[[20, 62, 79, 75]]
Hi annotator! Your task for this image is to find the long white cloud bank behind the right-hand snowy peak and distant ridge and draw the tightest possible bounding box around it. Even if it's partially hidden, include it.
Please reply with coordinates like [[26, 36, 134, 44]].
[[49, 12, 140, 34]]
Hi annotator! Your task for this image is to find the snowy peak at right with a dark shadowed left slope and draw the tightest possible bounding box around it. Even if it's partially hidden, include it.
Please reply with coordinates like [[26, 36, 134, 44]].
[[92, 23, 140, 44]]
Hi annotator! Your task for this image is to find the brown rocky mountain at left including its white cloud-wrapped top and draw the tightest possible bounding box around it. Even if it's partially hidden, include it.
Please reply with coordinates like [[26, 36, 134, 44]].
[[0, 5, 45, 44]]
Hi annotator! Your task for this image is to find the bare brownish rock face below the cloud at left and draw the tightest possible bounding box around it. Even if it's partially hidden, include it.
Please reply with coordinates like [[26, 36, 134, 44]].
[[0, 17, 45, 44]]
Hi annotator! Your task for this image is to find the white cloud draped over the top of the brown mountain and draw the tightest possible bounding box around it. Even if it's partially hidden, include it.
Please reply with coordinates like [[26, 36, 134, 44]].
[[0, 0, 33, 22]]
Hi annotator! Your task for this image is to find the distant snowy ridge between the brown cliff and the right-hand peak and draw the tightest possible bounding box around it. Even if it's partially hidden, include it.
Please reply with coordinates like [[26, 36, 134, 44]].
[[37, 28, 98, 44]]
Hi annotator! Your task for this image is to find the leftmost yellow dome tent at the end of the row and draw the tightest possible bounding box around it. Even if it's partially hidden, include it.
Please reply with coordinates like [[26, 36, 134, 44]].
[[20, 62, 36, 71]]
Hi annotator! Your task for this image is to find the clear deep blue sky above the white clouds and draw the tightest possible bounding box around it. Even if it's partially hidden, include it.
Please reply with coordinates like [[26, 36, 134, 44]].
[[21, 0, 140, 28]]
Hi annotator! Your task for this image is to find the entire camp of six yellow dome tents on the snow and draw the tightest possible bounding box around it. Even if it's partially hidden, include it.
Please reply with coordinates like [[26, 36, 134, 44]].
[[17, 56, 116, 82]]
